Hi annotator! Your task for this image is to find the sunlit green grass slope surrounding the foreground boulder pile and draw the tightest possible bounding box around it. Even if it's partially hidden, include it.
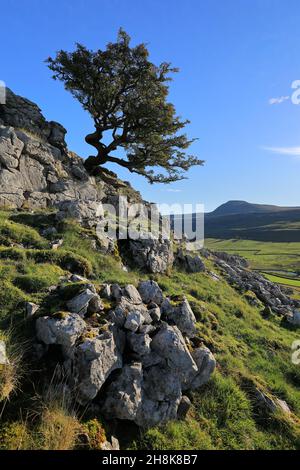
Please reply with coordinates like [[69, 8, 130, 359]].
[[0, 212, 300, 449]]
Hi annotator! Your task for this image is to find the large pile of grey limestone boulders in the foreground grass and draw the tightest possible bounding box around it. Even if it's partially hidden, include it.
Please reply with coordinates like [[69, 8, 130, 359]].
[[35, 280, 216, 428]]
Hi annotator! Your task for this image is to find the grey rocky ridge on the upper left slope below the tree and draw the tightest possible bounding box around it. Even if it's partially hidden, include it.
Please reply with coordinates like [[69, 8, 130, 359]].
[[0, 89, 173, 273]]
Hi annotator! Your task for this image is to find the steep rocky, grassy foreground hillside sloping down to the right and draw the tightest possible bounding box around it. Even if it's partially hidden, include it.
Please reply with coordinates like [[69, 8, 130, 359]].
[[0, 92, 300, 450]]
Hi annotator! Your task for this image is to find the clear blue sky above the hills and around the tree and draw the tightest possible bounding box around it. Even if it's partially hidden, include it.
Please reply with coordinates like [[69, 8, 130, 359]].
[[0, 0, 300, 210]]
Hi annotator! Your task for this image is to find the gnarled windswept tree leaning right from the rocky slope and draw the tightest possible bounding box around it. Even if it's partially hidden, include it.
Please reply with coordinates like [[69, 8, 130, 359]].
[[47, 30, 203, 183]]
